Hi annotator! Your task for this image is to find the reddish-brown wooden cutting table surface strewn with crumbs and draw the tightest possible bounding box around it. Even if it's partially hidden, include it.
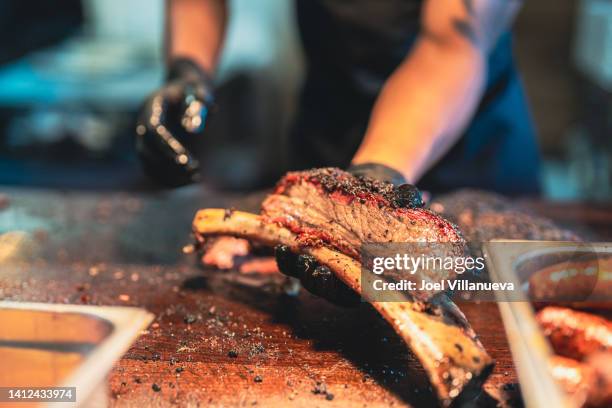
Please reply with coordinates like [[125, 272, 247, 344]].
[[0, 188, 612, 407]]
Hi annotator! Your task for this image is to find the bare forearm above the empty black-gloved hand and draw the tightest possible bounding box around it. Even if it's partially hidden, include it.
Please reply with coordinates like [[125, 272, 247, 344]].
[[166, 0, 227, 73]]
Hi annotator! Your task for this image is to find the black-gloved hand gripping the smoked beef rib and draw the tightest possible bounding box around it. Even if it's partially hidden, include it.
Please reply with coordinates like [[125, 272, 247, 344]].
[[274, 163, 424, 306]]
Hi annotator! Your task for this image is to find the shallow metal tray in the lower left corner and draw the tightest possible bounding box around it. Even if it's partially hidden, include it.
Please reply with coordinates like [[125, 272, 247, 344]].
[[0, 301, 153, 406]]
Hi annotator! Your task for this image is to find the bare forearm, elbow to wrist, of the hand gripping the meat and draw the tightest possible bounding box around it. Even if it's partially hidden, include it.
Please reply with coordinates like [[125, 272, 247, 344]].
[[353, 39, 486, 183]]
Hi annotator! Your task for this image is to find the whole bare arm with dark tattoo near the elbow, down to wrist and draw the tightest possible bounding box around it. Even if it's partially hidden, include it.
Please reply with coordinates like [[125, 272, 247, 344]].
[[353, 0, 521, 183]]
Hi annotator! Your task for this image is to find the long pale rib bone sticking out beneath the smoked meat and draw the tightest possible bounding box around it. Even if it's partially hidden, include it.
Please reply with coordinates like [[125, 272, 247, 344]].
[[193, 209, 492, 405]]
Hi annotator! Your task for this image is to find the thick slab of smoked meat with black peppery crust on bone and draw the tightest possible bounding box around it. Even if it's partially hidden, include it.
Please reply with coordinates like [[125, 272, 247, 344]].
[[262, 168, 464, 259]]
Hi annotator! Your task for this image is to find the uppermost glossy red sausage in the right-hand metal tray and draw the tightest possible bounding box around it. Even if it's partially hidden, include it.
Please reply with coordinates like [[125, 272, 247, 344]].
[[536, 306, 612, 360]]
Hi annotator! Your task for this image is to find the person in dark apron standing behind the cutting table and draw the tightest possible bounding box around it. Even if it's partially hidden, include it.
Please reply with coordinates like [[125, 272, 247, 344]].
[[137, 0, 539, 194]]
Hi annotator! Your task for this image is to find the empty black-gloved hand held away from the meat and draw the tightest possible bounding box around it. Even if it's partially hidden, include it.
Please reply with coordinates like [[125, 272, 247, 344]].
[[136, 58, 214, 187]]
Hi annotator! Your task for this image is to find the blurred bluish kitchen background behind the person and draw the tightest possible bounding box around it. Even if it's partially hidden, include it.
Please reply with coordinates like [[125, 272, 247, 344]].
[[0, 0, 612, 200]]
